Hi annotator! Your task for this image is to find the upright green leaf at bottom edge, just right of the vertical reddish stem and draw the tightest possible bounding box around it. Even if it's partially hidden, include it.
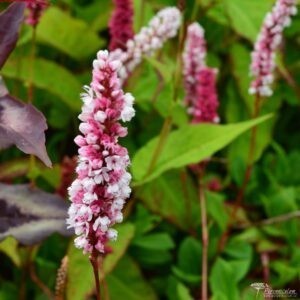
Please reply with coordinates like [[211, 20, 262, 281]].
[[209, 258, 239, 300]]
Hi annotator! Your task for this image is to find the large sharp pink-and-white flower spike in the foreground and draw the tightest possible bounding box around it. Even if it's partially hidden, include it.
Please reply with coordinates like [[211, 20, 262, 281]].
[[67, 51, 135, 253]]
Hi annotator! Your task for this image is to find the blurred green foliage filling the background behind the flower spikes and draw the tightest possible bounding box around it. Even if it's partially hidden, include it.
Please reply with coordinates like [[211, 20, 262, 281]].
[[0, 0, 300, 300]]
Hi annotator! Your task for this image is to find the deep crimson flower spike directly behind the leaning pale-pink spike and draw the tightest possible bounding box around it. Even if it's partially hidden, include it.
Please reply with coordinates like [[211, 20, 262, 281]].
[[109, 0, 134, 51]]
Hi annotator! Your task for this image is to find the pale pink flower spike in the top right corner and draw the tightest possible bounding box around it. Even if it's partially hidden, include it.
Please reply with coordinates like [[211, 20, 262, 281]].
[[249, 0, 297, 97]]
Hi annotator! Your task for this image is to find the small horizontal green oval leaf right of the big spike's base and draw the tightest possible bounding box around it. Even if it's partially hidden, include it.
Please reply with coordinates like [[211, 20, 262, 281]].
[[132, 233, 175, 250]]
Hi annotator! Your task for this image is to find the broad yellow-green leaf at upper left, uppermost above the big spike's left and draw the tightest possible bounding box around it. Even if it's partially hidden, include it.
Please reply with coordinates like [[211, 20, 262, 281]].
[[37, 6, 104, 60]]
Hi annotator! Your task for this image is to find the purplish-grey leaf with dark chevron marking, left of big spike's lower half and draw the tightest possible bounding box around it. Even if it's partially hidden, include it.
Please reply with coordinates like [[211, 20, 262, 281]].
[[0, 184, 74, 245]]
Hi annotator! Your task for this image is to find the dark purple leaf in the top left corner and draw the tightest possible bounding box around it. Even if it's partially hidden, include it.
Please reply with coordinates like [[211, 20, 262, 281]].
[[0, 3, 25, 69]]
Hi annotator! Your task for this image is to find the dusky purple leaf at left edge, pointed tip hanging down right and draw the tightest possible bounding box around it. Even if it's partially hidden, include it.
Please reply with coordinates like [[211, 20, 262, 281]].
[[0, 78, 52, 167]]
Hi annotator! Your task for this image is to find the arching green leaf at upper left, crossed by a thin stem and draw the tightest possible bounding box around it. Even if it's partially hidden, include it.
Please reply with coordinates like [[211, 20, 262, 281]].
[[2, 57, 82, 111]]
